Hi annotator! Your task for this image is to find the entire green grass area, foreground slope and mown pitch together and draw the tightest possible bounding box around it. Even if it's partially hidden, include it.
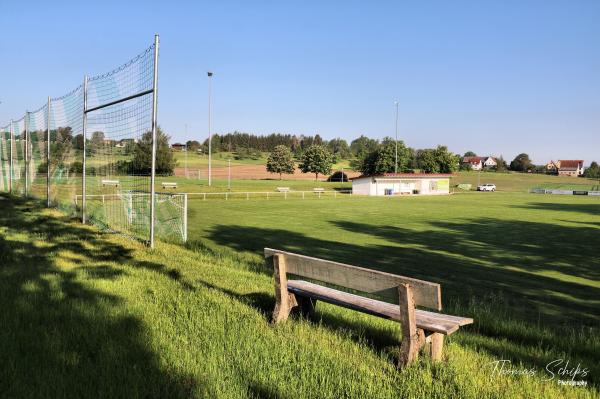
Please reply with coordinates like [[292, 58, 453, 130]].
[[0, 187, 600, 398]]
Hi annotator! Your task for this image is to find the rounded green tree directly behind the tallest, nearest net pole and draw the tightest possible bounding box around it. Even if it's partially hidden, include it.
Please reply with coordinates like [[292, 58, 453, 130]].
[[131, 127, 177, 175]]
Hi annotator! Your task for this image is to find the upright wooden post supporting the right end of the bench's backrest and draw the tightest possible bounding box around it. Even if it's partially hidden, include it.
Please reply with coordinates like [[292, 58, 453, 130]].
[[398, 284, 424, 366]]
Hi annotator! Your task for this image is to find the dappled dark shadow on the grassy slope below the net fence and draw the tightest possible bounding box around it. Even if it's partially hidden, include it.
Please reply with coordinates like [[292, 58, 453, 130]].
[[0, 197, 196, 398]]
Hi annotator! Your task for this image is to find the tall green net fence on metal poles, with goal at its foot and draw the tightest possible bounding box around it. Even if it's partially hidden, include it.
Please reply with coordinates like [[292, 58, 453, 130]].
[[0, 35, 187, 247]]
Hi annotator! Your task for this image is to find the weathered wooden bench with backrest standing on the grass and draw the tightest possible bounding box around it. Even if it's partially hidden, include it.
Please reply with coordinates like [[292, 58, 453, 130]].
[[264, 248, 473, 365]]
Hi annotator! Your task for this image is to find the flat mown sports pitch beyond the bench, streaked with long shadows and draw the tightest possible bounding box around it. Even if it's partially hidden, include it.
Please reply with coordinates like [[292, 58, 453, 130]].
[[188, 193, 600, 325]]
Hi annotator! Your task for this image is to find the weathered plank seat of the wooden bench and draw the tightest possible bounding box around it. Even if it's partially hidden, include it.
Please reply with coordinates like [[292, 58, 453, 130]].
[[288, 280, 473, 335]]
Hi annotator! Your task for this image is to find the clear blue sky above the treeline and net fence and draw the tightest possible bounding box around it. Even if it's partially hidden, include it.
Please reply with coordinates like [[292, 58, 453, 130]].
[[0, 0, 600, 164]]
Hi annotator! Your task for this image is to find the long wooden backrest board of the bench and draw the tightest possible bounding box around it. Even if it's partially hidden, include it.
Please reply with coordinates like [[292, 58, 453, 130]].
[[265, 248, 442, 310]]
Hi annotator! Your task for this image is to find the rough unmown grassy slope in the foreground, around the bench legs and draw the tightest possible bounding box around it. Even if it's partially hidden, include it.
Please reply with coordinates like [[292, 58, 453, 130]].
[[0, 197, 598, 398]]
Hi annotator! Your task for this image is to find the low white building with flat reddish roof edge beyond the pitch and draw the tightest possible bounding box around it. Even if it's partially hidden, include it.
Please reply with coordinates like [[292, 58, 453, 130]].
[[352, 173, 452, 195]]
